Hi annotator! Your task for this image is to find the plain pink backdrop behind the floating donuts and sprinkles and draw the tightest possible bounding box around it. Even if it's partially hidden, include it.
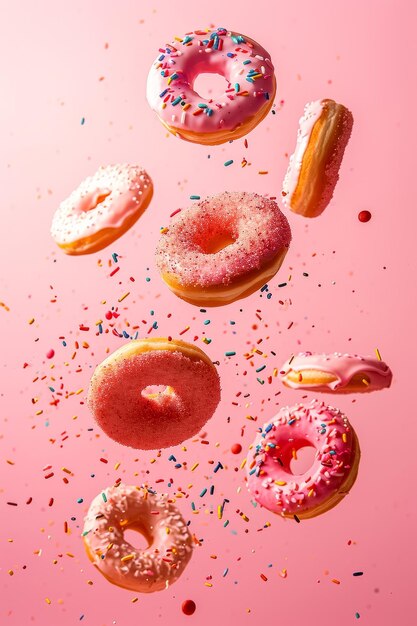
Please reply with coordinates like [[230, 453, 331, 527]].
[[0, 0, 417, 626]]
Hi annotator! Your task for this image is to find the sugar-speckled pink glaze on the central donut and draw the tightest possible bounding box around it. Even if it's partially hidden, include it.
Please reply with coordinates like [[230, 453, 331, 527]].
[[156, 192, 291, 287]]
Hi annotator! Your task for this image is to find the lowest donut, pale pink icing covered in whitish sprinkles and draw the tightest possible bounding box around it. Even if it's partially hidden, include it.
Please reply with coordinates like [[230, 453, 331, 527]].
[[83, 484, 193, 593]]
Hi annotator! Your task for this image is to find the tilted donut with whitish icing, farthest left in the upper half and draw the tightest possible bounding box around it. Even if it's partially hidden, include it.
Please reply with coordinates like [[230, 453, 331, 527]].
[[51, 165, 153, 255]]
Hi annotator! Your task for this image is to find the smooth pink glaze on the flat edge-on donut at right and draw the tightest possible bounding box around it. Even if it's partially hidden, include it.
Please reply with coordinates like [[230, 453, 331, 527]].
[[279, 352, 392, 391]]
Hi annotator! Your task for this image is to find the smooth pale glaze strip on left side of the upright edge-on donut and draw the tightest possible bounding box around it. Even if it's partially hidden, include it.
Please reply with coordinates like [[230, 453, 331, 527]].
[[282, 100, 324, 208]]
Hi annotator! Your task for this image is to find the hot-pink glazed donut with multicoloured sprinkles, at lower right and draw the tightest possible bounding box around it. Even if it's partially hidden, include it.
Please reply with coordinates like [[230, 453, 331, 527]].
[[246, 400, 360, 521]]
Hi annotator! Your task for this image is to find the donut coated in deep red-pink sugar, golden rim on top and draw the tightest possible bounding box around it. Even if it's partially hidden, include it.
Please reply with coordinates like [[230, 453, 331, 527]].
[[87, 338, 220, 450]]
